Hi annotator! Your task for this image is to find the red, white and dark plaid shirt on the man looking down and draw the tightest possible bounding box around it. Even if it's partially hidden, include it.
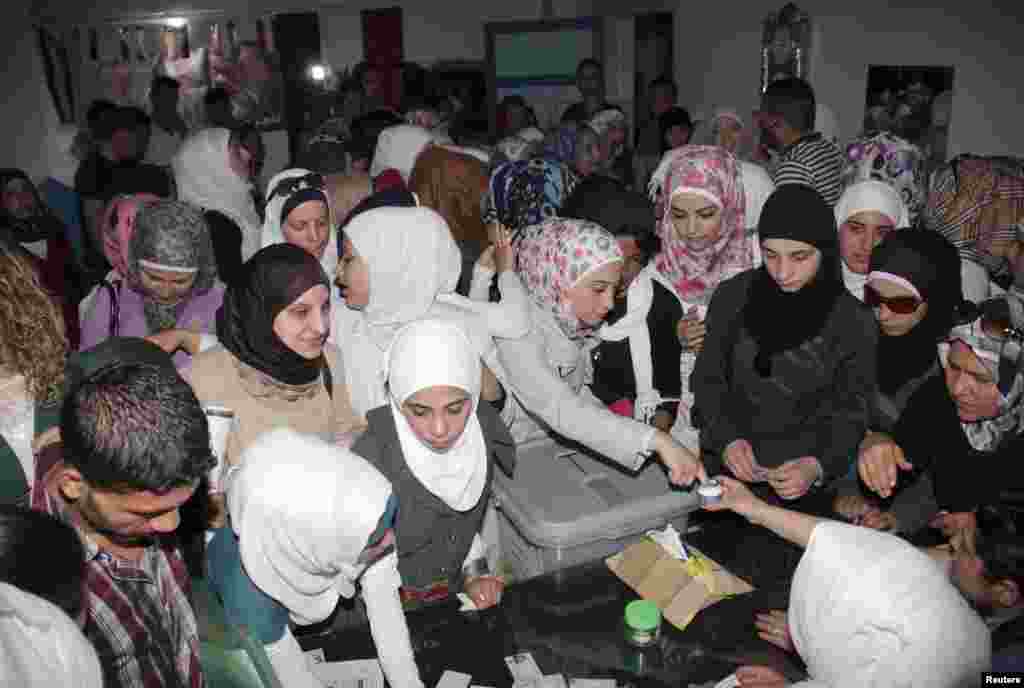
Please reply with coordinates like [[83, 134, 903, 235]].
[[32, 445, 203, 688]]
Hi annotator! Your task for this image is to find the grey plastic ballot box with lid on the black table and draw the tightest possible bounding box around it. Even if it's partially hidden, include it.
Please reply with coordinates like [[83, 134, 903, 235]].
[[494, 437, 700, 581]]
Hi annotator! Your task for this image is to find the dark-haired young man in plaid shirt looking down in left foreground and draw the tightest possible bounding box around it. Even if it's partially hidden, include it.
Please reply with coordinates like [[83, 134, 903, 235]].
[[32, 338, 214, 688]]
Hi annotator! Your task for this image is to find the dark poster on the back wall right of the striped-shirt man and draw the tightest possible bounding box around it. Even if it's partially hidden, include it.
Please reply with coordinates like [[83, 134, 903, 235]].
[[864, 65, 953, 169]]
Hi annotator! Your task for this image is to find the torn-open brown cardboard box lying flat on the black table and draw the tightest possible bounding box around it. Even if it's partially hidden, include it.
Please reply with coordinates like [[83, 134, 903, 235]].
[[605, 538, 754, 630]]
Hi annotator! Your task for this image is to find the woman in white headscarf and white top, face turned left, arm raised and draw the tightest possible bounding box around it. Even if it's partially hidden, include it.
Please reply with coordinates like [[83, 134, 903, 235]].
[[332, 207, 528, 416]]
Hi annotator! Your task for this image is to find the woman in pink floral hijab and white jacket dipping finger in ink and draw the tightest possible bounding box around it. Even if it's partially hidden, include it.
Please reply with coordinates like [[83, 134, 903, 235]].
[[498, 218, 707, 485]]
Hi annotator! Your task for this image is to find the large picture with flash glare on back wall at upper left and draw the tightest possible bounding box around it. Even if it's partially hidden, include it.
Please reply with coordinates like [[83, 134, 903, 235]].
[[79, 14, 284, 130]]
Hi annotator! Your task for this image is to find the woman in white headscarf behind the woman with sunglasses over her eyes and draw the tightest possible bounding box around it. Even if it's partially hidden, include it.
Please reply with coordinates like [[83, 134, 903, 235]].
[[836, 179, 910, 301]]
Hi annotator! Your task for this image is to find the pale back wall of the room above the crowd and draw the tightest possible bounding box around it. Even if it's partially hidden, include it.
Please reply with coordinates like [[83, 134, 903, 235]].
[[14, 0, 1024, 174]]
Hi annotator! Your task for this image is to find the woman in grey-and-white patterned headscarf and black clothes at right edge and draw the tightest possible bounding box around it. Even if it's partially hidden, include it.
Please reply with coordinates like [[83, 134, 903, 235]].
[[858, 270, 1024, 534]]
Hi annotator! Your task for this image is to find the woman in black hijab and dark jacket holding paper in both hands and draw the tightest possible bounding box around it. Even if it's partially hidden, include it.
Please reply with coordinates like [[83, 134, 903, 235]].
[[690, 184, 878, 510]]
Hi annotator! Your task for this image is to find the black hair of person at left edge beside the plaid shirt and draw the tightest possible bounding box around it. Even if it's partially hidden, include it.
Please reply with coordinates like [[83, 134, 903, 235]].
[[0, 505, 85, 618]]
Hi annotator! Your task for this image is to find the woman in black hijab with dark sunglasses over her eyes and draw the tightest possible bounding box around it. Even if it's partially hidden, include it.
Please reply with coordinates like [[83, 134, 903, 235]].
[[835, 231, 963, 533]]
